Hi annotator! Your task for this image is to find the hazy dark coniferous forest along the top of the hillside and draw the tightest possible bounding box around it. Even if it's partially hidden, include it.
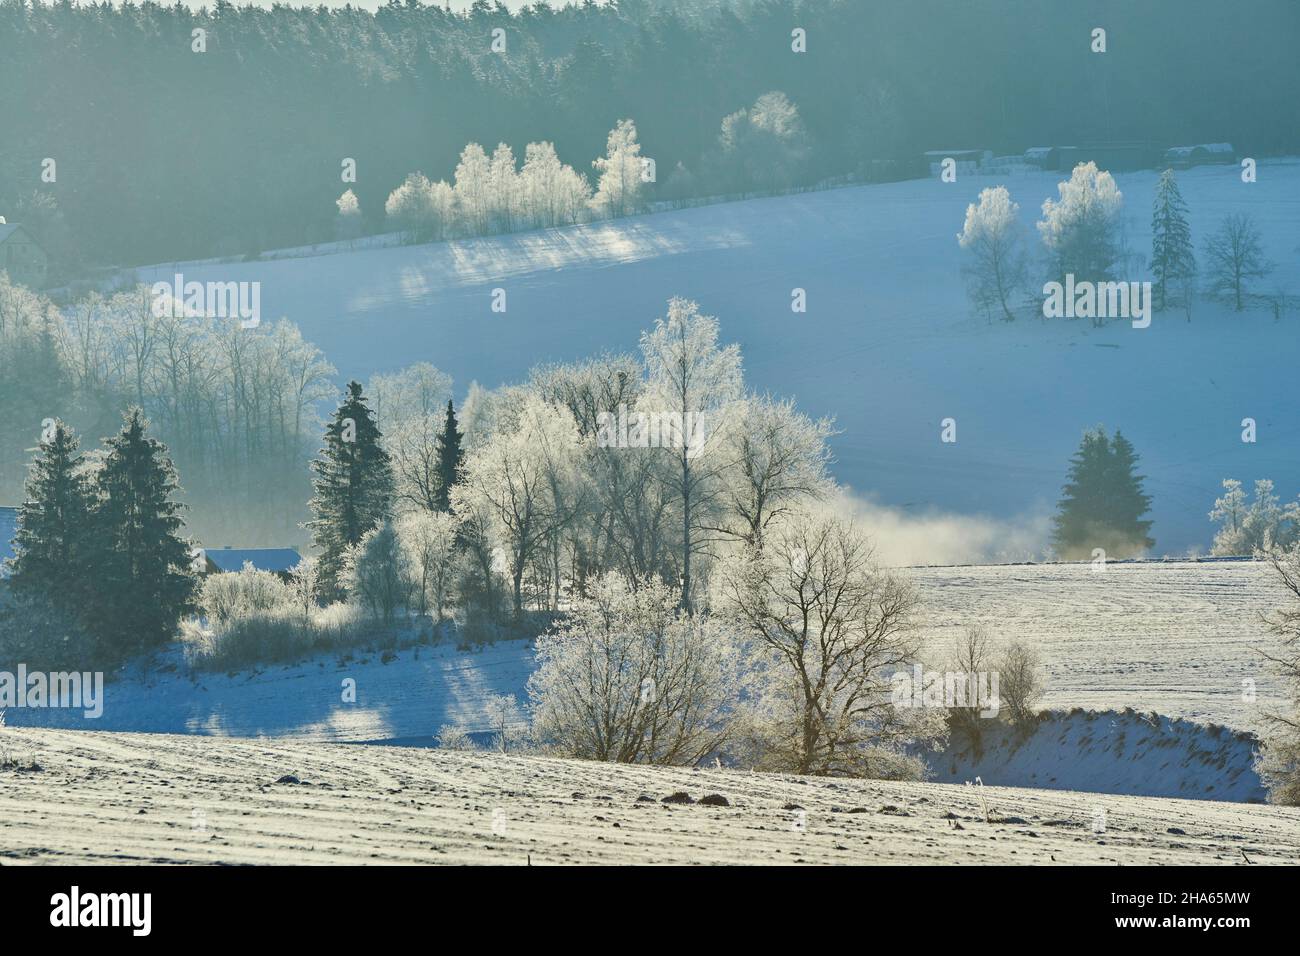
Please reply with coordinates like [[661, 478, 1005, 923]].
[[0, 0, 1300, 276]]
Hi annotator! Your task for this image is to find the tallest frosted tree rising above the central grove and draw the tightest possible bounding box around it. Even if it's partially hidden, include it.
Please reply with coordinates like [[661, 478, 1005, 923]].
[[638, 298, 744, 609]]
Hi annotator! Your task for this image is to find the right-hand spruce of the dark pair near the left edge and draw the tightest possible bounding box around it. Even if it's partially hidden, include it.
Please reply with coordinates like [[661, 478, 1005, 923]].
[[87, 408, 198, 656]]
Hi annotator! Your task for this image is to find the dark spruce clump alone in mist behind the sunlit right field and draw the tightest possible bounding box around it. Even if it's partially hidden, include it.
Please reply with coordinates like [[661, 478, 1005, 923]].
[[1052, 425, 1156, 558]]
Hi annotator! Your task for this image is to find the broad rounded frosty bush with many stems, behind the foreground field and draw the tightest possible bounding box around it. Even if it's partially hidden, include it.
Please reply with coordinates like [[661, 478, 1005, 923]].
[[528, 575, 740, 766]]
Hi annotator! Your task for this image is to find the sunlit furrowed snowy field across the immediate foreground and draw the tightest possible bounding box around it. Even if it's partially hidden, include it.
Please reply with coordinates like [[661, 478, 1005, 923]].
[[0, 728, 1300, 865]]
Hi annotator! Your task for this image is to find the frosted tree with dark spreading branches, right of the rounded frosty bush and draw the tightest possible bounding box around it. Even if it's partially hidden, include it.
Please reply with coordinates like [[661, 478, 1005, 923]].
[[720, 510, 943, 778]]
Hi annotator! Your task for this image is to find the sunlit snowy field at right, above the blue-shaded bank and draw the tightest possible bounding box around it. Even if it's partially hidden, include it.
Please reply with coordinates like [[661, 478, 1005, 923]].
[[907, 561, 1288, 731]]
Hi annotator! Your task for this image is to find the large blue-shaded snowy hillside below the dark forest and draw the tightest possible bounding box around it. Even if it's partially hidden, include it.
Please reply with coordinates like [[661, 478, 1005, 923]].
[[140, 160, 1300, 563]]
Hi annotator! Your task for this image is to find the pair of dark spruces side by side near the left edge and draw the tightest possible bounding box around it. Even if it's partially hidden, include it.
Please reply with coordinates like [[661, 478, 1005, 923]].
[[0, 408, 196, 667]]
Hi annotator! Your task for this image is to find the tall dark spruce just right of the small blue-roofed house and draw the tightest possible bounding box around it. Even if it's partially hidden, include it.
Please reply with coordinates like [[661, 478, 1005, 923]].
[[307, 381, 395, 601]]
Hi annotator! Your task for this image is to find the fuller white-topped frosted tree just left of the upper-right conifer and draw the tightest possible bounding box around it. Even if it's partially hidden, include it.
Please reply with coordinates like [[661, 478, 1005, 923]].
[[1037, 163, 1123, 282]]
